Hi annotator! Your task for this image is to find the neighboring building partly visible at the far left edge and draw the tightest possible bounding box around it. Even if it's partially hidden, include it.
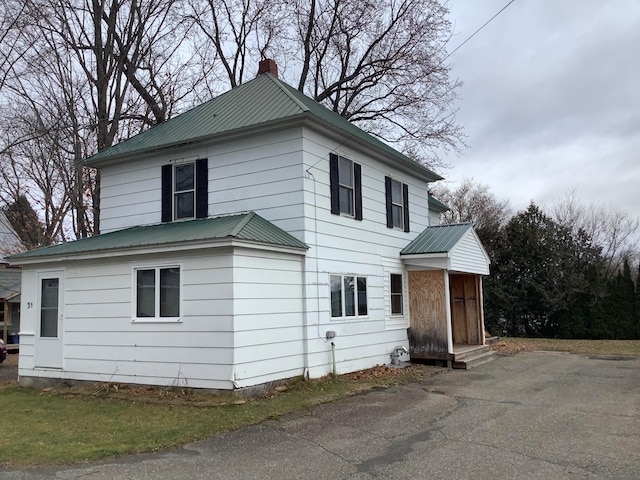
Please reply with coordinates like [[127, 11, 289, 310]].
[[0, 211, 25, 350]]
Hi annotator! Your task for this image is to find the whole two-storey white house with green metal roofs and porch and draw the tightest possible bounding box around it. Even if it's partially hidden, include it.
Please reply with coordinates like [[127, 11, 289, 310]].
[[12, 61, 489, 390]]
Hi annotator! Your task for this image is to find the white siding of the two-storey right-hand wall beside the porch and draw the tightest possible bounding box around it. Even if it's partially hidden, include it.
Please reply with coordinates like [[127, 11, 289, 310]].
[[304, 129, 429, 376]]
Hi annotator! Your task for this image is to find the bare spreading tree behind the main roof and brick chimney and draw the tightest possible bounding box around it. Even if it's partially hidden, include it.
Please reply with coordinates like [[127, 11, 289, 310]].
[[189, 0, 462, 166]]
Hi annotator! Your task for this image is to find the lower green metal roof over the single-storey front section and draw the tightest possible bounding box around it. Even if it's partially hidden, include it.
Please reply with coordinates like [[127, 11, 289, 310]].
[[10, 212, 309, 264]]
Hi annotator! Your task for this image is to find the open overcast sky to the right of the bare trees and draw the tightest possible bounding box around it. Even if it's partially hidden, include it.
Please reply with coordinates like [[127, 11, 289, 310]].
[[443, 0, 640, 216]]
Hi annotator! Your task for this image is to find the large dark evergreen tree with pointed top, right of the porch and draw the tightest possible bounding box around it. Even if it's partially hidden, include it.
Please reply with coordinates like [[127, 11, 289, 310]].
[[485, 203, 600, 337]]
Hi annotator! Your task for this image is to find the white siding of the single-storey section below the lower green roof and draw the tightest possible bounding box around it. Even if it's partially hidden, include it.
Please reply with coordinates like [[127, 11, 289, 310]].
[[20, 244, 303, 389]]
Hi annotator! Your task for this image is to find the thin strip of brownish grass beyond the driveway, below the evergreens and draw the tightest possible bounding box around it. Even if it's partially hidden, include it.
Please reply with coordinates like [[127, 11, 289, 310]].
[[500, 337, 640, 356]]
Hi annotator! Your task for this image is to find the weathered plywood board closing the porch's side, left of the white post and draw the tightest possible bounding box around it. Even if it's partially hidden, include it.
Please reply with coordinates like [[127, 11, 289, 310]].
[[409, 270, 448, 354]]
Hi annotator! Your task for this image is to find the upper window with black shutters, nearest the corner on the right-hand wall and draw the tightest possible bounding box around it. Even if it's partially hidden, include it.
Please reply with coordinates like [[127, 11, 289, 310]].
[[329, 153, 362, 220]]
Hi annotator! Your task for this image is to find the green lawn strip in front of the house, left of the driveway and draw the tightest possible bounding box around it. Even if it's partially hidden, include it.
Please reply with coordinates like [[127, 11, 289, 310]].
[[0, 375, 417, 467]]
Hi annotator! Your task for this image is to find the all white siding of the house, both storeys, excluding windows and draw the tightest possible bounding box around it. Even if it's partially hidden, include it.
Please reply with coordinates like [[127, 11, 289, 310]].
[[20, 127, 444, 389]]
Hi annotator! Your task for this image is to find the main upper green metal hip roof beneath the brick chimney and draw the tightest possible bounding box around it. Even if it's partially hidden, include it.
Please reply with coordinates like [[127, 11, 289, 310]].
[[85, 74, 442, 181]]
